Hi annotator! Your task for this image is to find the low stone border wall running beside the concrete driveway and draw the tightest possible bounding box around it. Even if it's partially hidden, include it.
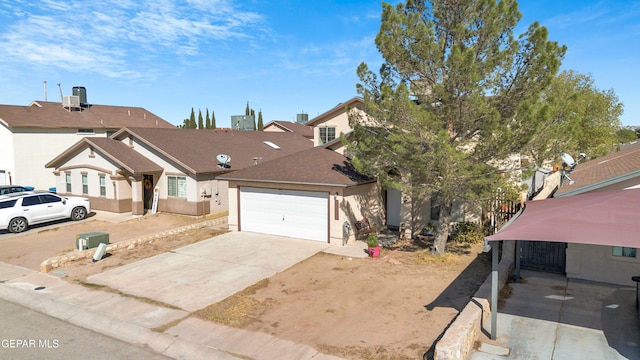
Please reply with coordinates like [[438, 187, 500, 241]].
[[40, 216, 228, 273]]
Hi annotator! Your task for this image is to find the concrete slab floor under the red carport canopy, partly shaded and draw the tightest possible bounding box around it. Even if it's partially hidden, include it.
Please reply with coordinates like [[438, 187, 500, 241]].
[[471, 271, 640, 360]]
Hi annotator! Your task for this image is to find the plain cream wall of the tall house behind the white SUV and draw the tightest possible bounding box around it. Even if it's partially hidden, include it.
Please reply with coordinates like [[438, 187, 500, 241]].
[[12, 129, 107, 190]]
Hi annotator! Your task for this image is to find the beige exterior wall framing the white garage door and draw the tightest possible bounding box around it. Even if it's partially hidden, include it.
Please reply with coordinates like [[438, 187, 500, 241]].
[[228, 181, 382, 244]]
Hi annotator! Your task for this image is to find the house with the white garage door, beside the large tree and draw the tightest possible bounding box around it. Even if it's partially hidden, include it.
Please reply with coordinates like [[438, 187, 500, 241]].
[[217, 147, 380, 244]]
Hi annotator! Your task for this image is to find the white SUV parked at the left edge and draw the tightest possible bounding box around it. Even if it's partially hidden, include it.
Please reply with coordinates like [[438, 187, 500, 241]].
[[0, 191, 91, 233]]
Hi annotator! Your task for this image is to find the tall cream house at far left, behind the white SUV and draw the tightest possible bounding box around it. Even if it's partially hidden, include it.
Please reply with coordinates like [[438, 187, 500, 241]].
[[0, 97, 175, 189]]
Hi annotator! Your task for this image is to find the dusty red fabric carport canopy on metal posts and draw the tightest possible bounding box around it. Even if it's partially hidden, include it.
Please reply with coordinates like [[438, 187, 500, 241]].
[[485, 189, 640, 248]]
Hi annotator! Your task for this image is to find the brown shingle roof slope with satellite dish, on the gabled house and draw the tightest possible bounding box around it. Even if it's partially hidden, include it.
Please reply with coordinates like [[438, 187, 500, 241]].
[[113, 128, 313, 174]]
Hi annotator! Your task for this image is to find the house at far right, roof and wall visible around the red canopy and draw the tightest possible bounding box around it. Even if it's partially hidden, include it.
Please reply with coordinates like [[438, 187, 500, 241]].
[[553, 142, 640, 285]]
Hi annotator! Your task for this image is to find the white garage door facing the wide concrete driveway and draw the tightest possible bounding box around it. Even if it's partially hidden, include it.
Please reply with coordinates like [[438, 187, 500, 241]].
[[240, 187, 329, 242]]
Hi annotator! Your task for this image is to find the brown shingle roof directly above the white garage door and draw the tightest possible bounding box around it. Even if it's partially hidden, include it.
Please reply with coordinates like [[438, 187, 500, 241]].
[[217, 147, 375, 187]]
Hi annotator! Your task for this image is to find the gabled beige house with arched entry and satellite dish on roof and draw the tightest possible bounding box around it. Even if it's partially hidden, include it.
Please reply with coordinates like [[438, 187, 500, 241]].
[[46, 127, 313, 215]]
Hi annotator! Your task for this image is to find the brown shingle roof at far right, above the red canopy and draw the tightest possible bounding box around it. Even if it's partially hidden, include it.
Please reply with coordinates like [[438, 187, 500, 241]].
[[555, 142, 640, 195]]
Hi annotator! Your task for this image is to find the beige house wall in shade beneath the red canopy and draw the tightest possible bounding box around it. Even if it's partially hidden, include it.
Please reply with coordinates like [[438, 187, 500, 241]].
[[566, 244, 640, 287]]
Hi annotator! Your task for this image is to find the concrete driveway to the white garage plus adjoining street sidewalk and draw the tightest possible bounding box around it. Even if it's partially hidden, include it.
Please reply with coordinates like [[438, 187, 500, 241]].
[[0, 232, 366, 359]]
